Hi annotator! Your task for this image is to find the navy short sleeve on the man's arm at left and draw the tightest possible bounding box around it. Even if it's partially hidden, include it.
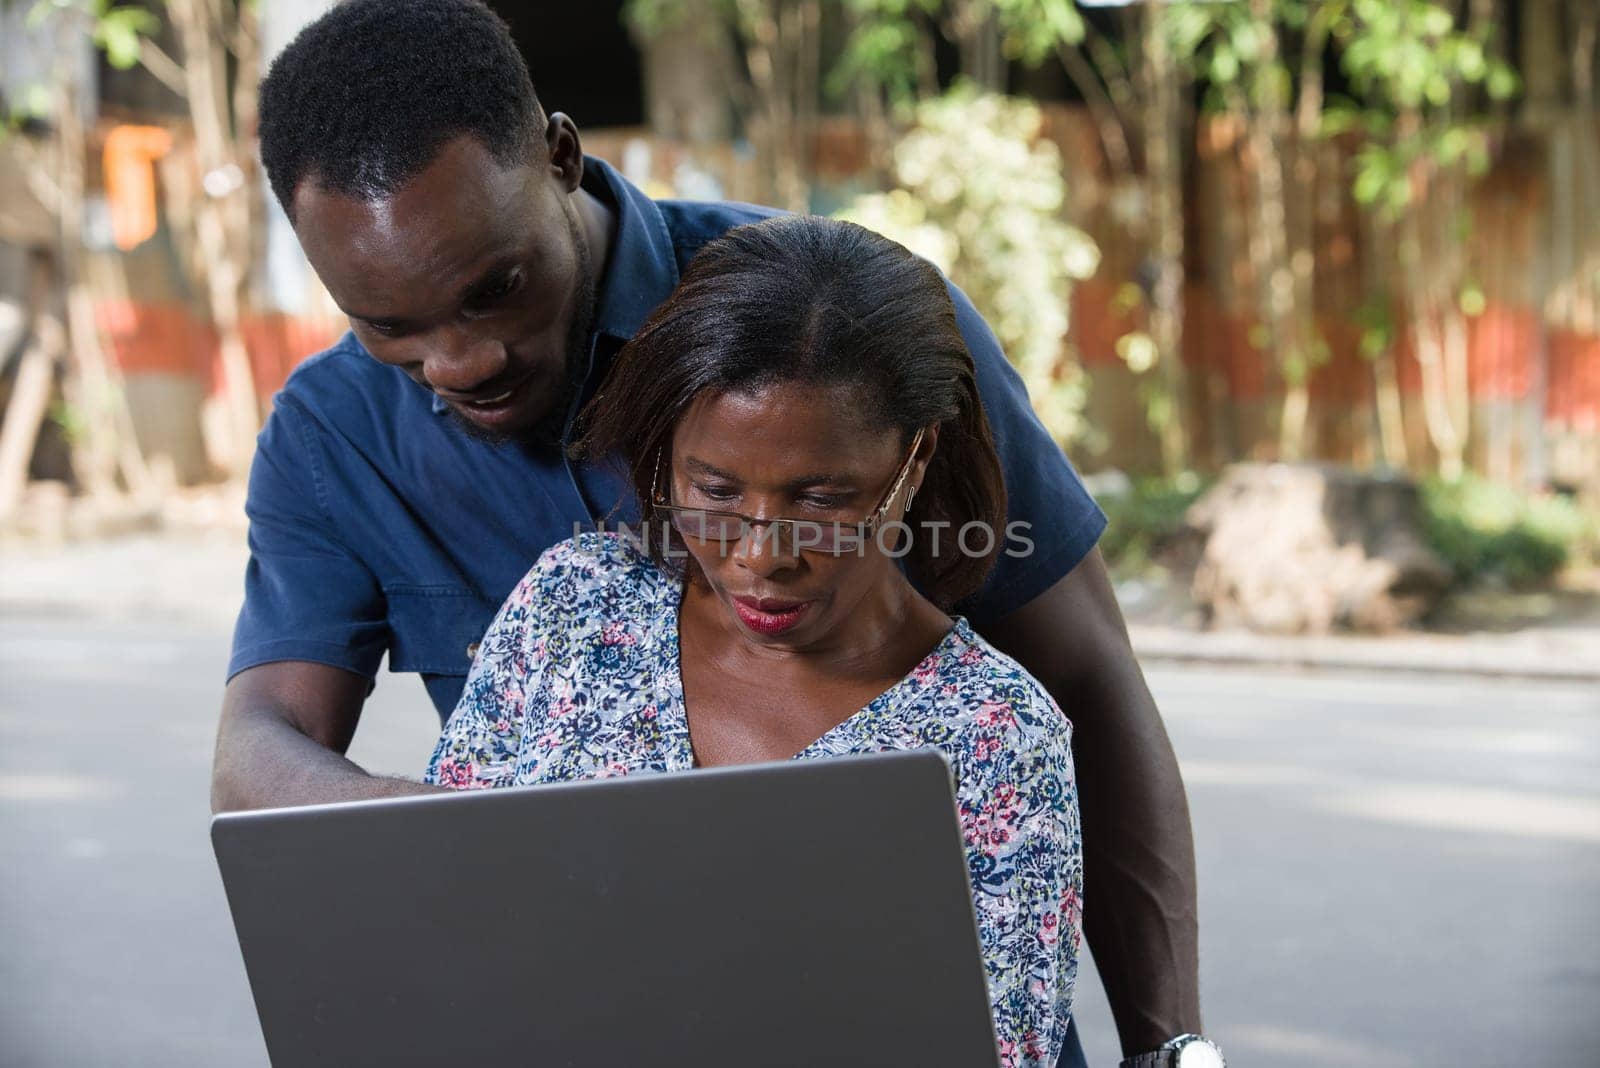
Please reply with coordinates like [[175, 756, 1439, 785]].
[[227, 395, 389, 679]]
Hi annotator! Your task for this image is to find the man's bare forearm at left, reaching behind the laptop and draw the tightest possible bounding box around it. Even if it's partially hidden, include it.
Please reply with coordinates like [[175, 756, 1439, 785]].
[[211, 660, 442, 812]]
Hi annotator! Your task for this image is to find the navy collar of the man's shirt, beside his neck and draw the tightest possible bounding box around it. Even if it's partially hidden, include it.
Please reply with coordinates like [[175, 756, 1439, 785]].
[[434, 155, 678, 414]]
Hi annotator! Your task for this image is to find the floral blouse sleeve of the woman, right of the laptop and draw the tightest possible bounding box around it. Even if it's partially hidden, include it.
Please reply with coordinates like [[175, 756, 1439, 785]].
[[958, 700, 1083, 1068]]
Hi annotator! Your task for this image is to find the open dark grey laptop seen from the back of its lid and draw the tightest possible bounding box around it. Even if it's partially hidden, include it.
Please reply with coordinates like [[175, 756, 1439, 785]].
[[211, 750, 998, 1068]]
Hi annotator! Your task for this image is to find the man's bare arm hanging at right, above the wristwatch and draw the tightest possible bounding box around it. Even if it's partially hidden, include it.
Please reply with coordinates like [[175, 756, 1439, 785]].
[[984, 550, 1200, 1057]]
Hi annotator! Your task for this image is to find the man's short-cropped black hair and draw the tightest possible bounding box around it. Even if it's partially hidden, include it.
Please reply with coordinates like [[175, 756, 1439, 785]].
[[261, 0, 544, 216]]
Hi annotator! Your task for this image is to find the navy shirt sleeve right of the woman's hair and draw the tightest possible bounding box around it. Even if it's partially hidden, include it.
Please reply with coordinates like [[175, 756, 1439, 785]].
[[950, 285, 1106, 630]]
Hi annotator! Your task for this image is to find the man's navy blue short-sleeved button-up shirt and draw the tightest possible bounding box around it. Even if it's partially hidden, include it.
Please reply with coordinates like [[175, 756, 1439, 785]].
[[229, 158, 1106, 719]]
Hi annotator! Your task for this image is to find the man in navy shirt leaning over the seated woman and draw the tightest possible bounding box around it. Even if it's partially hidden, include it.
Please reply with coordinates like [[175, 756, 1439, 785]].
[[213, 0, 1200, 1068]]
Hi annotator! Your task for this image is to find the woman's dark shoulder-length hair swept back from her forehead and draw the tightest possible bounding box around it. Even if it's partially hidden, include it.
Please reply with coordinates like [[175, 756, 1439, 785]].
[[576, 216, 1006, 608]]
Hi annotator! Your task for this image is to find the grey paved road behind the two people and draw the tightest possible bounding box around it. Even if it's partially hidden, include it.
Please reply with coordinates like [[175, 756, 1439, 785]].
[[0, 614, 1600, 1068]]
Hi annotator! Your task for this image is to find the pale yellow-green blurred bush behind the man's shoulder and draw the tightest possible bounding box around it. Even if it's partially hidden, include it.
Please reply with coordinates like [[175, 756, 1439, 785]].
[[840, 85, 1099, 443]]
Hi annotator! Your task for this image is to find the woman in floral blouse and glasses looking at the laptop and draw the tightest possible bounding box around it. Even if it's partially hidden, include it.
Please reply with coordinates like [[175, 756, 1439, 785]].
[[429, 216, 1082, 1065]]
